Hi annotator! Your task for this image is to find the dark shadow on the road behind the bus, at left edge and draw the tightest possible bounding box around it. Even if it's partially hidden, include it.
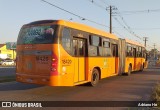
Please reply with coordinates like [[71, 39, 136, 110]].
[[0, 82, 43, 91]]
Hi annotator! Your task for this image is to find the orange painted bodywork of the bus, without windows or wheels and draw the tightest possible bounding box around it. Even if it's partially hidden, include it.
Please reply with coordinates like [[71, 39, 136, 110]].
[[16, 20, 148, 86]]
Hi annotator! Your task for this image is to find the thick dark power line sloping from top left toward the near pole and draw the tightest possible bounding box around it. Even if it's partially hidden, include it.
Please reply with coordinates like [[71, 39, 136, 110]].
[[41, 0, 108, 27]]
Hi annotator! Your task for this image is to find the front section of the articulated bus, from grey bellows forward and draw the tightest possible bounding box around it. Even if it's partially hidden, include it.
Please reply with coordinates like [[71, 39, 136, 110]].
[[119, 39, 147, 75]]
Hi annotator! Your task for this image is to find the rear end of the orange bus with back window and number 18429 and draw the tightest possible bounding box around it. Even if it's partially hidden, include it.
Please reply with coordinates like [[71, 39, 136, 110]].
[[16, 21, 62, 85]]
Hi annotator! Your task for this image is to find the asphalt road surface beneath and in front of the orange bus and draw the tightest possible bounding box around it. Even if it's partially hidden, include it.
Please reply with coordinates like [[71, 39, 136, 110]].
[[0, 69, 160, 101]]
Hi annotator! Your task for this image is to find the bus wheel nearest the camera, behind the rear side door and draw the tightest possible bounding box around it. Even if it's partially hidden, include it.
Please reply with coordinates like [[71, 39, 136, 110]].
[[90, 69, 99, 87]]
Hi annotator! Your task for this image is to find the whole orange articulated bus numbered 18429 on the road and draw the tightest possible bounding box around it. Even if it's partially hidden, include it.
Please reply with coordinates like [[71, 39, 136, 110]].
[[16, 20, 148, 86]]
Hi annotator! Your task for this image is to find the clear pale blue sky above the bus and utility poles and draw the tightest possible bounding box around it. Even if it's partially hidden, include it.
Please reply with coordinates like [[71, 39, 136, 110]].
[[0, 0, 160, 51]]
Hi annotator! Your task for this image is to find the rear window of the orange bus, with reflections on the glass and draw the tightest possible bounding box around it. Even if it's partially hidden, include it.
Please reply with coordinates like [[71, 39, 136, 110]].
[[17, 26, 55, 45]]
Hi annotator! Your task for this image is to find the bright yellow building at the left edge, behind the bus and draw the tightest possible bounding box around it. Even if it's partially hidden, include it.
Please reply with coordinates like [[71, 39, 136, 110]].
[[0, 44, 16, 59]]
